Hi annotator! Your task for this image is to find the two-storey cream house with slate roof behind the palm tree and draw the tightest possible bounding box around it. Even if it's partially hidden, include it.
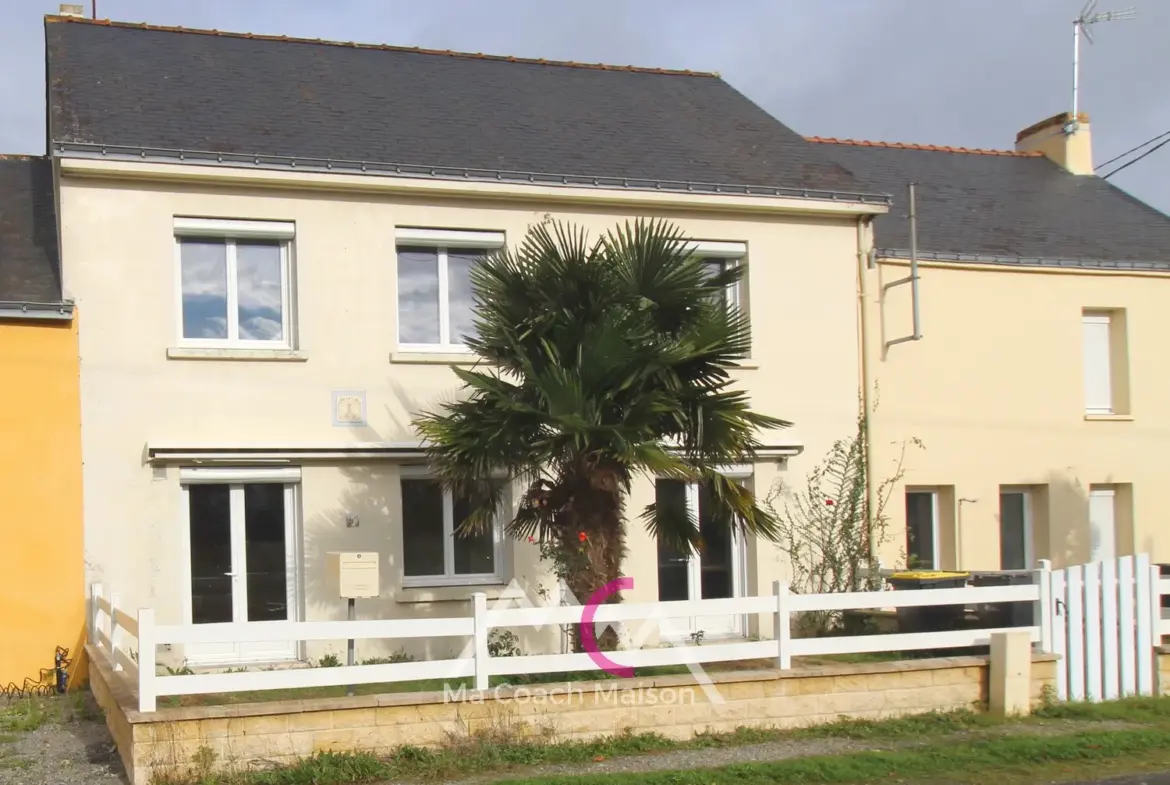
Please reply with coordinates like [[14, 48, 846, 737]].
[[46, 18, 888, 665]]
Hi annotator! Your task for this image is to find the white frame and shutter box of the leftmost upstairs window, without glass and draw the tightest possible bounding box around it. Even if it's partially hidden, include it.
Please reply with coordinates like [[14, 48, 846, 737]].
[[174, 216, 296, 349]]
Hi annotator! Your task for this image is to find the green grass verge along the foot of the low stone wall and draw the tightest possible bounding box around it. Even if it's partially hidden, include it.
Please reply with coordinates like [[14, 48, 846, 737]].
[[148, 698, 1170, 785]]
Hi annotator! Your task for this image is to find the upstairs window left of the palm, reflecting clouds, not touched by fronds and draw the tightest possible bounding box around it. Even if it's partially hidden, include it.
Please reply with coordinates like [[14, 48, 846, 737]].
[[174, 218, 294, 349]]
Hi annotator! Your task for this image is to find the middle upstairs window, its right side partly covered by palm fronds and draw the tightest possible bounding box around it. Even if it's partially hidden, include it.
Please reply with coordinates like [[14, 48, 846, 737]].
[[397, 228, 504, 352]]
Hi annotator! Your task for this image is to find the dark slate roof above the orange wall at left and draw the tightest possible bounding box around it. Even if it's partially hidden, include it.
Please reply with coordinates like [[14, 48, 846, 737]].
[[0, 156, 61, 303]]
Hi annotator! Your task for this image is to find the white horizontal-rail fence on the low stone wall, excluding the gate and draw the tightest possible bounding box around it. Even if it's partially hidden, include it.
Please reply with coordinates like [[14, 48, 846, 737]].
[[90, 570, 1051, 711]]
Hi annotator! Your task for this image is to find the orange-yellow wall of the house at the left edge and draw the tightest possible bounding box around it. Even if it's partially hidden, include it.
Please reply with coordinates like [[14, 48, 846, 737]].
[[0, 318, 85, 684]]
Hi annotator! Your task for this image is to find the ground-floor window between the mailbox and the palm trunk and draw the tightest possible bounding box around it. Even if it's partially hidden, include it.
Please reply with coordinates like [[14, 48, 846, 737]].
[[402, 469, 503, 586]]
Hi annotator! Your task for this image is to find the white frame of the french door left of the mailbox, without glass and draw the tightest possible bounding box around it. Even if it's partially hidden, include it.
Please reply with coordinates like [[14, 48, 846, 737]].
[[179, 467, 302, 666]]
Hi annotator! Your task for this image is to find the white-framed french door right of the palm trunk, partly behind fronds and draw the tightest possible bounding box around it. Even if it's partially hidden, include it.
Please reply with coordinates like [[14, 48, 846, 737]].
[[655, 480, 746, 640]]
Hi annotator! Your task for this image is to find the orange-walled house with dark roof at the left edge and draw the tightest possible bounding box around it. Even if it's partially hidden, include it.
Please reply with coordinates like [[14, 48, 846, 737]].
[[0, 156, 85, 687]]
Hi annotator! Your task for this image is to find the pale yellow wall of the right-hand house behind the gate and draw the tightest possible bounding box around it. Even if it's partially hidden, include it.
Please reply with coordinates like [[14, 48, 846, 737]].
[[867, 257, 1170, 570]]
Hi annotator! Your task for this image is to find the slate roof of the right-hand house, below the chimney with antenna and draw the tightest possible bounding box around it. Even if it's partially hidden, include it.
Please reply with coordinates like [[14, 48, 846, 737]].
[[811, 137, 1170, 269]]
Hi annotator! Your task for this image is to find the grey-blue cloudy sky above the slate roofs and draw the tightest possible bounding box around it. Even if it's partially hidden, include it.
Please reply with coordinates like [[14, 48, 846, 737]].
[[0, 0, 1170, 213]]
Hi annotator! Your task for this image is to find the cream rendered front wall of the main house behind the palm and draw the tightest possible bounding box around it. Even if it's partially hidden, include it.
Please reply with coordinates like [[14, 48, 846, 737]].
[[61, 172, 859, 655]]
